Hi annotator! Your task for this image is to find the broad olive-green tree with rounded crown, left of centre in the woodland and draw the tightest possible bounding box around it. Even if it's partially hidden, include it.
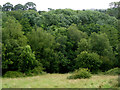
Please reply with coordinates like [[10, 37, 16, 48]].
[[27, 29, 58, 72]]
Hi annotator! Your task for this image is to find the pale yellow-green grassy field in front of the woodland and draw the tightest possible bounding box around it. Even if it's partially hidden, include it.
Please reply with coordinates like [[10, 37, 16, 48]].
[[2, 74, 118, 88]]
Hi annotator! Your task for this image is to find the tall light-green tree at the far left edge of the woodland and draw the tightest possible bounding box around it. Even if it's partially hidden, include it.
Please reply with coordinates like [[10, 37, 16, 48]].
[[2, 15, 27, 70]]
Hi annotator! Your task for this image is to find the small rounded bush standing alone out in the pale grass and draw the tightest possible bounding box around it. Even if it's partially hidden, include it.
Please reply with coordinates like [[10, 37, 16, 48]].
[[67, 68, 92, 79]]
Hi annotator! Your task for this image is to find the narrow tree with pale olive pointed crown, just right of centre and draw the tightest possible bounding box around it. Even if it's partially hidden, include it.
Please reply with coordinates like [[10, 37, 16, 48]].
[[66, 24, 88, 71]]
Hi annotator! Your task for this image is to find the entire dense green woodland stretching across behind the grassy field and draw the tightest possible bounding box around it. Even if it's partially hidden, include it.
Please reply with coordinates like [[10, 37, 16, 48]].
[[2, 2, 120, 74]]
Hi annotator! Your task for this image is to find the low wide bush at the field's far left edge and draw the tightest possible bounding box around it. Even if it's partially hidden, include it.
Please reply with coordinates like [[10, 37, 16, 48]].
[[3, 71, 24, 78]]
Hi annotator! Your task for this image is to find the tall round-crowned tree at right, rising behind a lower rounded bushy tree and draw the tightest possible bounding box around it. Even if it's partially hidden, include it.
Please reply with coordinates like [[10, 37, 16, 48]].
[[89, 33, 117, 70]]
